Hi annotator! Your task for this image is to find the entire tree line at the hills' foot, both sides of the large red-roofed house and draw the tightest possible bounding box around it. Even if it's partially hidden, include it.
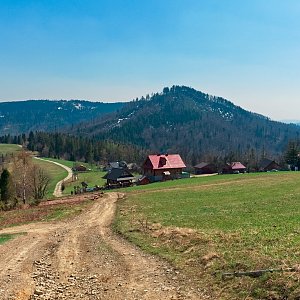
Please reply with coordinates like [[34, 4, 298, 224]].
[[0, 132, 300, 171]]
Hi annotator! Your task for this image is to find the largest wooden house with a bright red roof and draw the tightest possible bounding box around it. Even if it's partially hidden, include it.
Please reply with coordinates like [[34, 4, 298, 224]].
[[143, 154, 189, 182]]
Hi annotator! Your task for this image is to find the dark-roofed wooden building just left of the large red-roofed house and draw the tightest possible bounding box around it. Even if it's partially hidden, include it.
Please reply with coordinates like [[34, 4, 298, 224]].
[[103, 168, 135, 187]]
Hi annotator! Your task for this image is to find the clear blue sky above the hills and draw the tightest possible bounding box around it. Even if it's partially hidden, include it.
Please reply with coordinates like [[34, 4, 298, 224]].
[[0, 0, 300, 120]]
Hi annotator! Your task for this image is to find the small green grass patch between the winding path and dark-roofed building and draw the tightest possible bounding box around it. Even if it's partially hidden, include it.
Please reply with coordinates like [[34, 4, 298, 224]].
[[42, 158, 106, 195]]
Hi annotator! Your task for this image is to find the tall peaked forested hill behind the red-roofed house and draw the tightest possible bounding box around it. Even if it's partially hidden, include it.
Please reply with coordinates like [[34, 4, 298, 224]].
[[72, 86, 300, 163]]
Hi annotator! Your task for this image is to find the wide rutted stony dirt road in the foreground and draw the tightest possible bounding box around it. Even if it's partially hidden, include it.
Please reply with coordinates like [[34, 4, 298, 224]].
[[0, 193, 203, 300]]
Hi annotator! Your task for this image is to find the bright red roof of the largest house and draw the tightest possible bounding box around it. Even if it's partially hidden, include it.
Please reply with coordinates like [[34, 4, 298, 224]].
[[147, 154, 186, 170]]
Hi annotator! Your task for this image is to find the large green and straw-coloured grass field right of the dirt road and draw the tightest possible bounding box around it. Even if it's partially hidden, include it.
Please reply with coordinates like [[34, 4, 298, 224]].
[[114, 172, 300, 299]]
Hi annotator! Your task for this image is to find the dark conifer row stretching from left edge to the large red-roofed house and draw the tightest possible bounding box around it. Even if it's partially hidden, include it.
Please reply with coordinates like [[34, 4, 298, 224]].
[[0, 132, 145, 164]]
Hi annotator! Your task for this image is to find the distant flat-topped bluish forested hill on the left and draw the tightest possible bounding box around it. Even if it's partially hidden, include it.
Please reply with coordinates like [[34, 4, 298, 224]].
[[0, 100, 124, 135]]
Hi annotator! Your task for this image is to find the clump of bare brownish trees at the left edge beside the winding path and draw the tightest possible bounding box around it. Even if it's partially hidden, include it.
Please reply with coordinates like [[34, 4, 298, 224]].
[[0, 151, 50, 210]]
